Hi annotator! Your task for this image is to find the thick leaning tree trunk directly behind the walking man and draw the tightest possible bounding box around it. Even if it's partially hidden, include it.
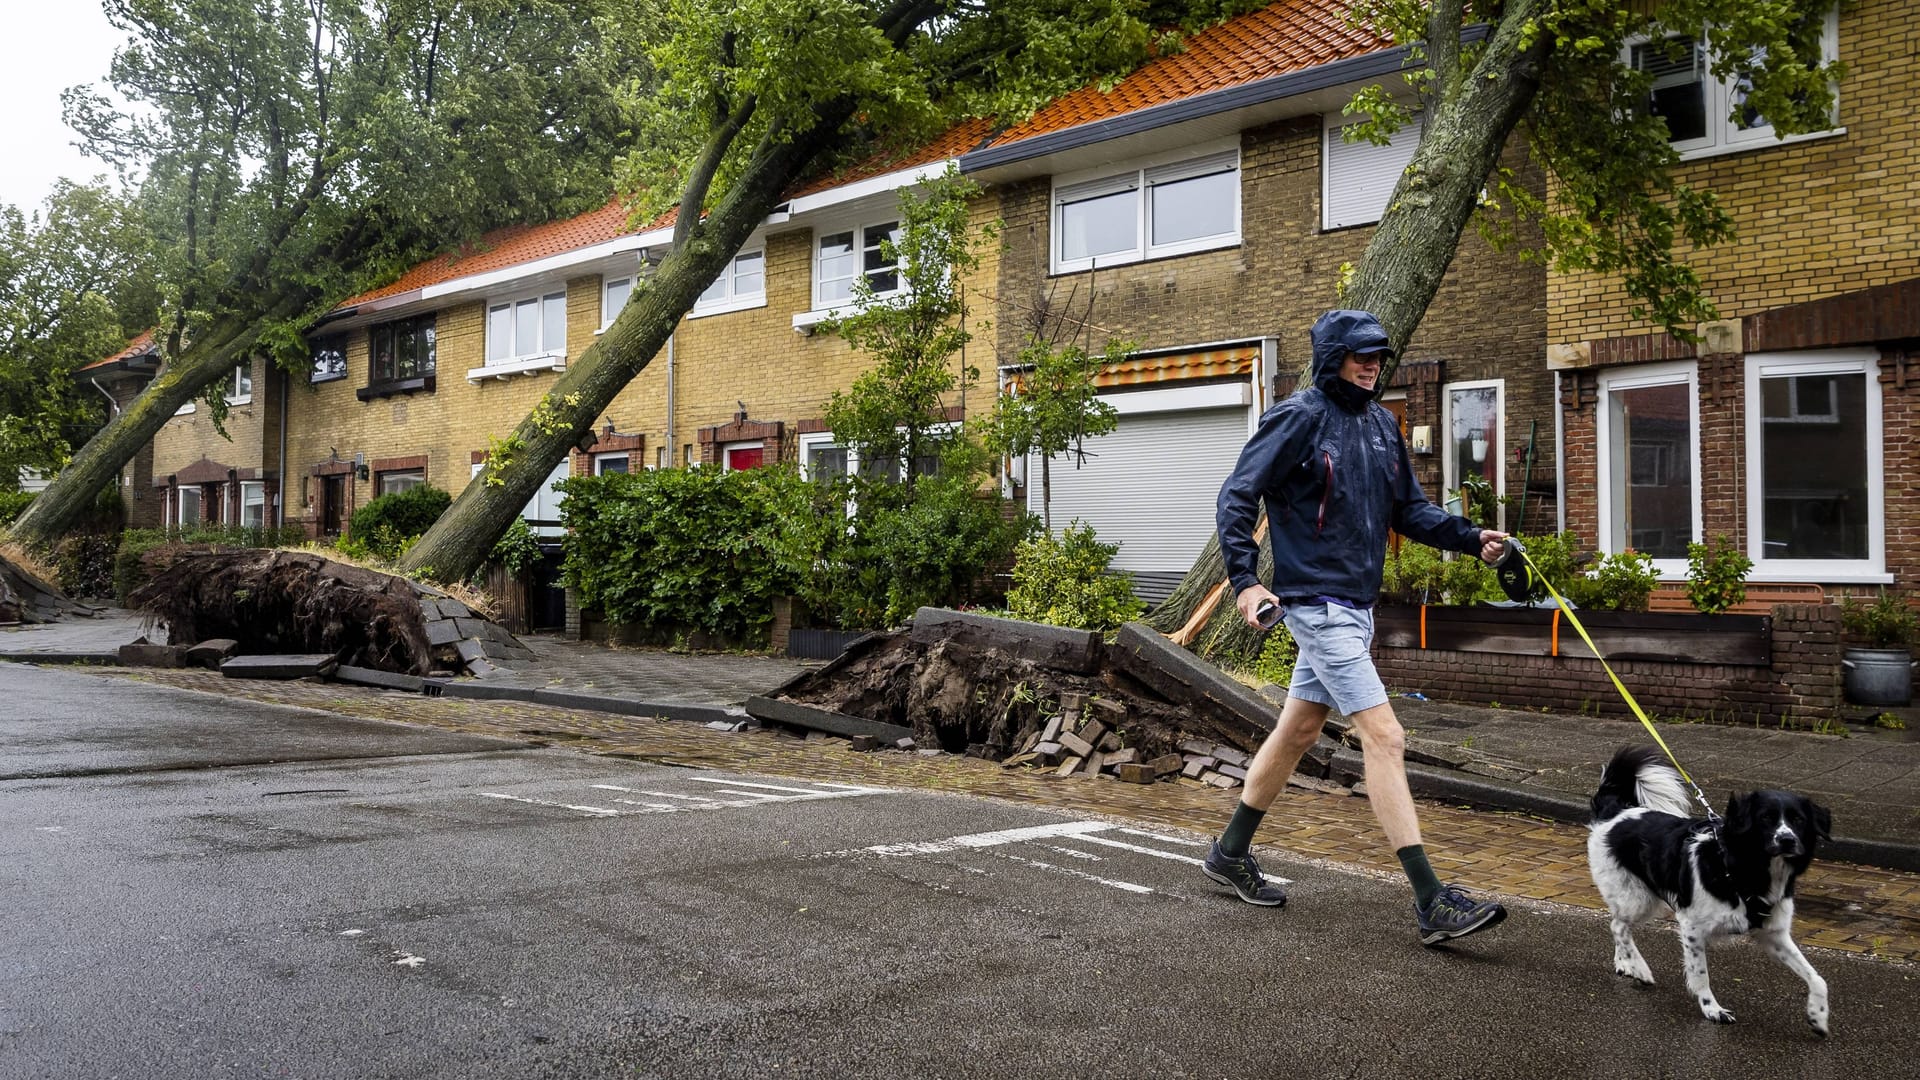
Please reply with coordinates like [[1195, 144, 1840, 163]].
[[1146, 0, 1553, 663]]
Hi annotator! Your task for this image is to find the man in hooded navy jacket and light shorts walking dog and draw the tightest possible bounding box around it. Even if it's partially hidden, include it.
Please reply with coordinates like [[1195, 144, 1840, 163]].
[[1200, 311, 1507, 945]]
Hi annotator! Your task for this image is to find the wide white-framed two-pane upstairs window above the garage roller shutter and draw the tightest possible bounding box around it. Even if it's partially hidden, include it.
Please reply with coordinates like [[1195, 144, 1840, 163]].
[[1052, 148, 1240, 273]]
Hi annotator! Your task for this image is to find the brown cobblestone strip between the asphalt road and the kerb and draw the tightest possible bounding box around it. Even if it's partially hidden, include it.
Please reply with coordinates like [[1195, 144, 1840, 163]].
[[63, 667, 1920, 963]]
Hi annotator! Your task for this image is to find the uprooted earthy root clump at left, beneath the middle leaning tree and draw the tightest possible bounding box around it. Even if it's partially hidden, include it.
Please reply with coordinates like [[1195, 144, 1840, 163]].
[[131, 548, 432, 675]]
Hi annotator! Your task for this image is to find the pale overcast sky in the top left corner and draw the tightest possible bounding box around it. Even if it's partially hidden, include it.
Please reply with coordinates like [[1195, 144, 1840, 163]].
[[0, 0, 121, 213]]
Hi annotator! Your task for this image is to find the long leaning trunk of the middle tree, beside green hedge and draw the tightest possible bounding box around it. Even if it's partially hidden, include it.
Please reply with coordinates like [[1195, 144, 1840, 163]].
[[399, 108, 851, 580]]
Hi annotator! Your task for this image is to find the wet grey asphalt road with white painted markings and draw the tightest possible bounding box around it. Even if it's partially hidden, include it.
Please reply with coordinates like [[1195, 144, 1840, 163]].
[[0, 663, 1920, 1080]]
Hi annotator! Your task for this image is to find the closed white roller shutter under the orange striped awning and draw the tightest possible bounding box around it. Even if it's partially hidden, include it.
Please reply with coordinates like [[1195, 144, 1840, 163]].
[[1027, 407, 1248, 573]]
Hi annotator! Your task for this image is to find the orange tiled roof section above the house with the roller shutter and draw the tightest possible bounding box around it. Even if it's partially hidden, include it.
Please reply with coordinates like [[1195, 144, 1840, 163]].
[[993, 0, 1392, 146]]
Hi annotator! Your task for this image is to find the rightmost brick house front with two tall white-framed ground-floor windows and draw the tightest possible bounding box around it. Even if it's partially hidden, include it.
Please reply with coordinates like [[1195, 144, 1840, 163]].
[[1548, 0, 1920, 596]]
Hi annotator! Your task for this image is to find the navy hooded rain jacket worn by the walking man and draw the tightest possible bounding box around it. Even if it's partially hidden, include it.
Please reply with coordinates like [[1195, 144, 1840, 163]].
[[1215, 311, 1480, 603]]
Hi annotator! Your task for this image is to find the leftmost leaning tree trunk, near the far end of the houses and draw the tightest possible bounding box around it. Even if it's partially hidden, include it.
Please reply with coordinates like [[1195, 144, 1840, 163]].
[[12, 319, 261, 548]]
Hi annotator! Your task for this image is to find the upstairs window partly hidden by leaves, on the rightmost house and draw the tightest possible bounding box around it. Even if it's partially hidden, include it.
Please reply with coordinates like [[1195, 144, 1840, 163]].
[[1626, 8, 1839, 158]]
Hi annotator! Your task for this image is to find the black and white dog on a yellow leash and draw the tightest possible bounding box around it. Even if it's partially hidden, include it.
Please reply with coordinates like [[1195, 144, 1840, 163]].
[[1586, 746, 1832, 1036]]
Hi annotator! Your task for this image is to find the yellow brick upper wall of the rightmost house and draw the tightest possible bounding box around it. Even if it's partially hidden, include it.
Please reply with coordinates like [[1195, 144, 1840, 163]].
[[1548, 0, 1920, 342]]
